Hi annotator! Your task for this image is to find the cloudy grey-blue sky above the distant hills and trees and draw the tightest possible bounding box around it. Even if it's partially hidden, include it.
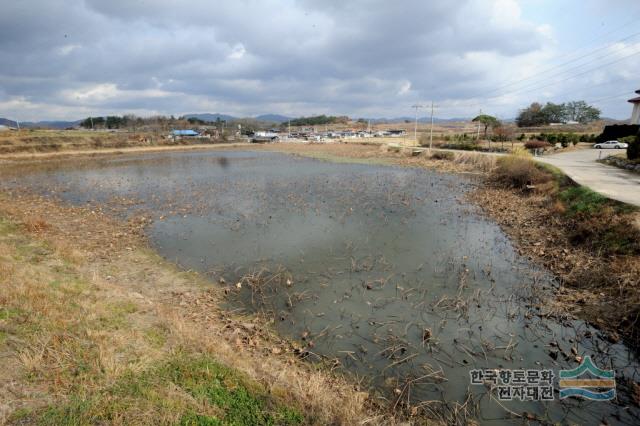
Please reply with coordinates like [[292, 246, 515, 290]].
[[0, 0, 640, 121]]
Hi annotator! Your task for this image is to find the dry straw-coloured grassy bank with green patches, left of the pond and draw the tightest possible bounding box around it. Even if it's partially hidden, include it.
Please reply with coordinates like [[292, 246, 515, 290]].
[[0, 194, 380, 425]]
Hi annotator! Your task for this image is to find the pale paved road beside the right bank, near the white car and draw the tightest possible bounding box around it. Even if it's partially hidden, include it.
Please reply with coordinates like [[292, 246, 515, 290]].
[[538, 149, 640, 206]]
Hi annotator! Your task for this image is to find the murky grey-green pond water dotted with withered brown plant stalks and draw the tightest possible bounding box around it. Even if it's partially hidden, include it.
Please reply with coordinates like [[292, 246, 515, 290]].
[[3, 152, 639, 424]]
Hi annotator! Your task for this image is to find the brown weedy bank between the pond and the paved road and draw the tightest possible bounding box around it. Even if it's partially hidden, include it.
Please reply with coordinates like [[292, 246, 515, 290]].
[[472, 153, 640, 347]]
